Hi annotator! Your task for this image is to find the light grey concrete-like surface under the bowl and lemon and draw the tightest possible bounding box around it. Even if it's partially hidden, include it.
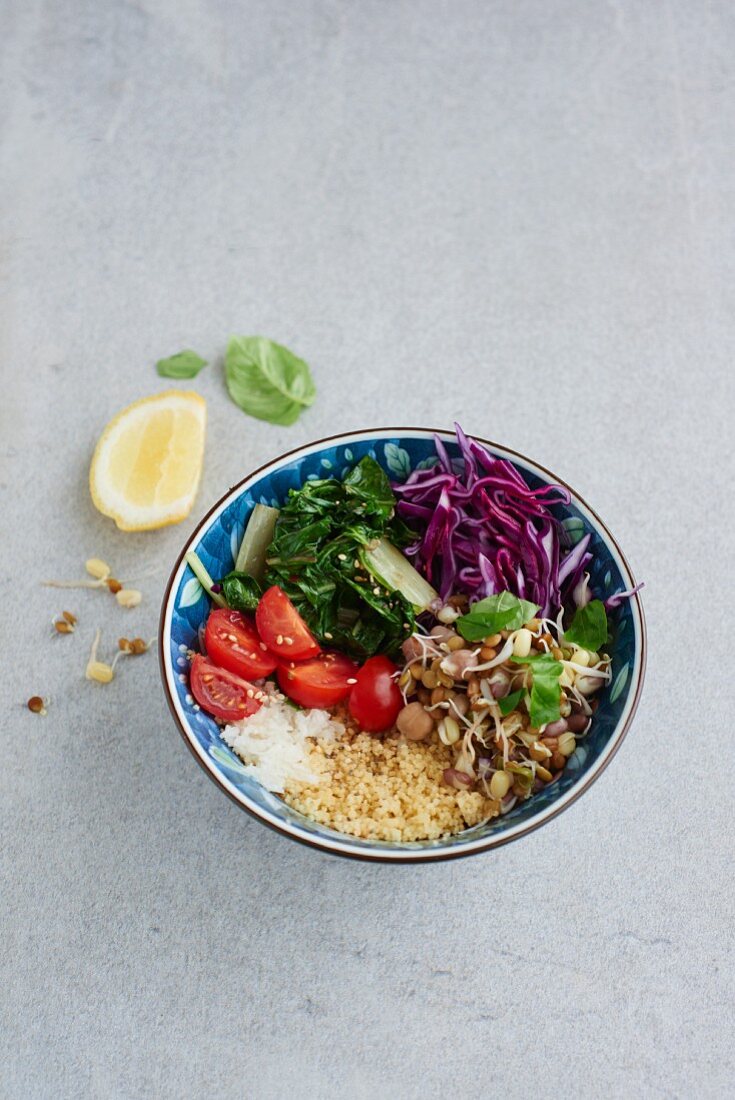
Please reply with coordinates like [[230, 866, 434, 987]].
[[0, 0, 735, 1100]]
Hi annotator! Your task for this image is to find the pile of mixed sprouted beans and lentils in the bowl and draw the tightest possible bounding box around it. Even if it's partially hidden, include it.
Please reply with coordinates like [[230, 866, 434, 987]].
[[398, 602, 611, 814]]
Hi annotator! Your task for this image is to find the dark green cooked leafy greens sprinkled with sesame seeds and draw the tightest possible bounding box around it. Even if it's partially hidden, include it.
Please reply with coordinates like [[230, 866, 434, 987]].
[[265, 457, 415, 658]]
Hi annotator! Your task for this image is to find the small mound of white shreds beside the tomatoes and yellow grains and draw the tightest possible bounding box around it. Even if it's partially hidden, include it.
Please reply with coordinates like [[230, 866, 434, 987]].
[[222, 695, 344, 794]]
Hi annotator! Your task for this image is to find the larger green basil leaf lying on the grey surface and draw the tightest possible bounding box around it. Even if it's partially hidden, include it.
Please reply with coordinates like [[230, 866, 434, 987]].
[[224, 337, 317, 425]]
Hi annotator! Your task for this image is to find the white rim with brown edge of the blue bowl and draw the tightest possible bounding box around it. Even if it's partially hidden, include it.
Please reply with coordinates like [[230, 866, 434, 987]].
[[158, 427, 648, 864]]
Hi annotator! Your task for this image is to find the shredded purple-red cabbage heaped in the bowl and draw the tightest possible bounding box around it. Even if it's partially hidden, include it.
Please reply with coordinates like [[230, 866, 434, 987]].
[[393, 425, 637, 617]]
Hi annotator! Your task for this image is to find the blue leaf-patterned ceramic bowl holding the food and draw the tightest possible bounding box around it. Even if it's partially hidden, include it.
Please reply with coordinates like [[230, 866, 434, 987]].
[[158, 428, 646, 862]]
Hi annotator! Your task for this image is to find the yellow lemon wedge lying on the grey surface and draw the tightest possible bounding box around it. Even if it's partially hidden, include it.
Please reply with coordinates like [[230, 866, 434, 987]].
[[89, 389, 207, 531]]
